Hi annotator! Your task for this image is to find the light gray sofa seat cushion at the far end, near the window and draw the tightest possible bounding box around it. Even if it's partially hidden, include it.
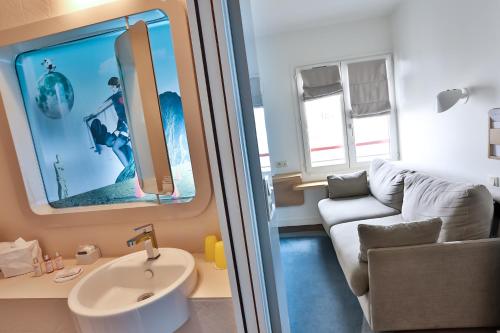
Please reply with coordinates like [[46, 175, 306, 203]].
[[318, 195, 400, 233]]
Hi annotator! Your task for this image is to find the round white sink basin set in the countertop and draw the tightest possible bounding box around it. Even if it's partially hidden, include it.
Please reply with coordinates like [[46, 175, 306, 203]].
[[68, 248, 197, 333]]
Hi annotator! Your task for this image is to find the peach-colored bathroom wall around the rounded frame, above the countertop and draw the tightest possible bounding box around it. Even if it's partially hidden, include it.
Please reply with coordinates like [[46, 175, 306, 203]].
[[0, 0, 219, 257]]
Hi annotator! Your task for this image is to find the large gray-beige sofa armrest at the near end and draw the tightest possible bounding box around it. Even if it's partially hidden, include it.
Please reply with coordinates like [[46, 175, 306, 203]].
[[368, 239, 500, 331]]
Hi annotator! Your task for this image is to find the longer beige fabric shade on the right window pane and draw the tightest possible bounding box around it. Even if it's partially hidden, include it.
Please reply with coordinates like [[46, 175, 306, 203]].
[[347, 59, 391, 118]]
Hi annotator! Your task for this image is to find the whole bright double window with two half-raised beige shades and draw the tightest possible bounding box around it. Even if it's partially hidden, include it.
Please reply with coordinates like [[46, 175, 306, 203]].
[[297, 56, 397, 173]]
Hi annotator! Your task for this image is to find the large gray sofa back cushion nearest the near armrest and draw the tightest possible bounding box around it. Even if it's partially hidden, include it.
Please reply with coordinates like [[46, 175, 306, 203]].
[[402, 173, 493, 242]]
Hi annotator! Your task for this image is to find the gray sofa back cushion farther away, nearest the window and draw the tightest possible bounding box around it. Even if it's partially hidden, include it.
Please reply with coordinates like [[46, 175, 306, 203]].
[[370, 159, 413, 211]]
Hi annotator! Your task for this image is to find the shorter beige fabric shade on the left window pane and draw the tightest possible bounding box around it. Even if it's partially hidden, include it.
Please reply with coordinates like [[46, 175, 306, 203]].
[[300, 65, 342, 101]]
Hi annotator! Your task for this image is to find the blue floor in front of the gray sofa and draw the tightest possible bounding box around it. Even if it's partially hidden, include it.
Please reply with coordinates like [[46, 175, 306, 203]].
[[280, 235, 363, 333]]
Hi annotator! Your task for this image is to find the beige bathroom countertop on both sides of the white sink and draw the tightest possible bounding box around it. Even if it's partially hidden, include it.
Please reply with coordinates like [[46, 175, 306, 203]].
[[0, 254, 231, 299]]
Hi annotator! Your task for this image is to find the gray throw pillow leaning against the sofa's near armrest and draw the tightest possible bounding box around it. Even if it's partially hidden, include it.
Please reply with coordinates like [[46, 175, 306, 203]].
[[358, 217, 443, 261]]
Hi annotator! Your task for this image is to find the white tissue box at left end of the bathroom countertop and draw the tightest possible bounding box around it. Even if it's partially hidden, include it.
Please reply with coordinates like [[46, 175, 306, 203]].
[[0, 238, 42, 278]]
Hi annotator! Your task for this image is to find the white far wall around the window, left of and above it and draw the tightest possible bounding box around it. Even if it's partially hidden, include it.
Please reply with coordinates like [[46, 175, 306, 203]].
[[254, 13, 392, 225]]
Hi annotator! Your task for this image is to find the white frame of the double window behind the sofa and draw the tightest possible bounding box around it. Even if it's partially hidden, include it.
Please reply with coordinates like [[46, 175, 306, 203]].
[[295, 53, 400, 178]]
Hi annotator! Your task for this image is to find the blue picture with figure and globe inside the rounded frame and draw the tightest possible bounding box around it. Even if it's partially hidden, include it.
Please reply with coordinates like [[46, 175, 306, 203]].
[[16, 11, 195, 208]]
